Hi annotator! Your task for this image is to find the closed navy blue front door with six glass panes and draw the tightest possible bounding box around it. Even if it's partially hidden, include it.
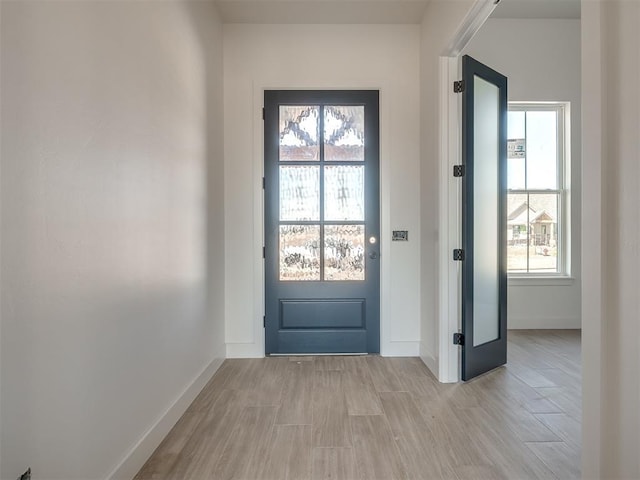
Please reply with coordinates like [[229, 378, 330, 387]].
[[264, 90, 380, 354]]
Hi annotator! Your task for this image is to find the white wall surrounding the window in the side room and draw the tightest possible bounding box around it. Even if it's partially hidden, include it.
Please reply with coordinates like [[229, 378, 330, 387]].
[[464, 18, 582, 328]]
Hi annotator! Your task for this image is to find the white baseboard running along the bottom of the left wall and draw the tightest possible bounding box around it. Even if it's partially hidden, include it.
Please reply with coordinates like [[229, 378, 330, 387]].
[[106, 351, 225, 480]]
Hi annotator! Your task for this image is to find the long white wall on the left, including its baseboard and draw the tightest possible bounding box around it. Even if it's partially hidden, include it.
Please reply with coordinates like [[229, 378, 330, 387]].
[[0, 1, 225, 480]]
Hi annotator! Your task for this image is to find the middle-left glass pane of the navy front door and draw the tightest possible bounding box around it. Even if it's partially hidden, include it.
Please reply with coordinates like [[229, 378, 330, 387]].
[[280, 165, 320, 221]]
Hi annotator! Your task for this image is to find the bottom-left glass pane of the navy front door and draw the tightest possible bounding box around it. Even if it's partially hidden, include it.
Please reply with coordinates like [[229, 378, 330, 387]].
[[280, 225, 320, 281]]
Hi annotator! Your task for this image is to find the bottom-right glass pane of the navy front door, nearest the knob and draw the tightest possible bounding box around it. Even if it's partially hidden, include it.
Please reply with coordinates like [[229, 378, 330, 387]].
[[324, 225, 365, 280]]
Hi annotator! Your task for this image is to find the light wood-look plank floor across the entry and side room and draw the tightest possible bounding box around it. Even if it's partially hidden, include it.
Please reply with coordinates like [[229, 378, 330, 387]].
[[135, 330, 581, 480]]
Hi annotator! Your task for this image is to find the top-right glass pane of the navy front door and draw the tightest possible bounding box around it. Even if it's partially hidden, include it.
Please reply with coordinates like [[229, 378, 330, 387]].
[[324, 105, 364, 161]]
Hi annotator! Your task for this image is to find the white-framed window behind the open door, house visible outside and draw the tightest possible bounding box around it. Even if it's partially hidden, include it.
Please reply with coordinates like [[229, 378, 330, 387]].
[[507, 102, 569, 276]]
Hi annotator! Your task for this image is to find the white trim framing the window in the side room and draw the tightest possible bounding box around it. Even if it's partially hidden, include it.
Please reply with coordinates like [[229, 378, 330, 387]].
[[507, 101, 574, 286]]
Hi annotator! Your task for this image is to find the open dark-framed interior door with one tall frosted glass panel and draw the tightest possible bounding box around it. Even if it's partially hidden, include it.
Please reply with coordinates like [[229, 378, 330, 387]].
[[461, 56, 507, 380]]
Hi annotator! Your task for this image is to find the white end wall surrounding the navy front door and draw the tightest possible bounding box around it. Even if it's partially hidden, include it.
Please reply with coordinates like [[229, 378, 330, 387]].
[[224, 24, 428, 357]]
